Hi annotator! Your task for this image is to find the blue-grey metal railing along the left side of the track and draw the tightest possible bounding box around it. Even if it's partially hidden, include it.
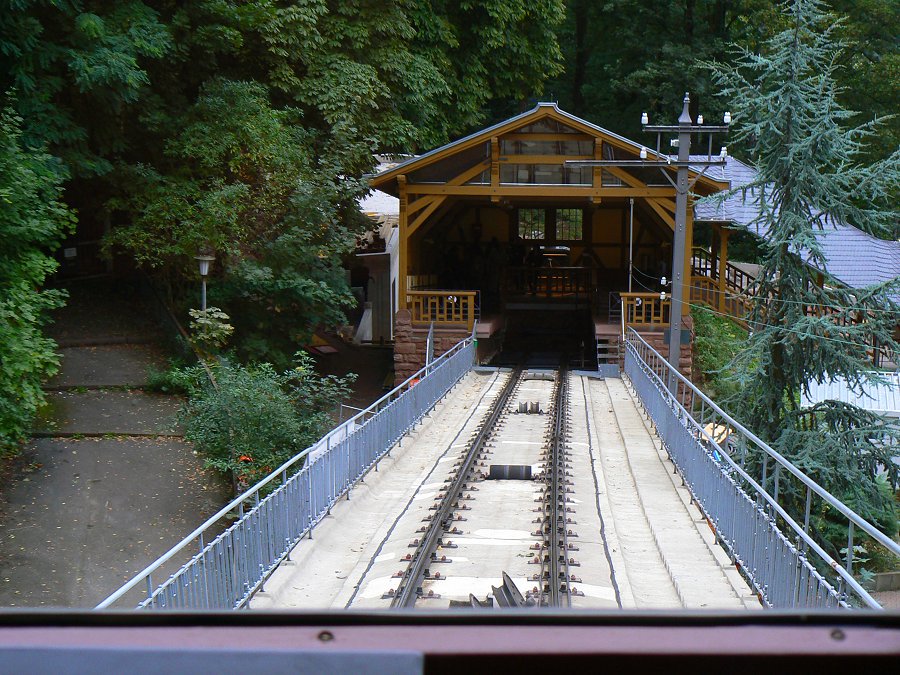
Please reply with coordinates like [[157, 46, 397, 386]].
[[96, 337, 475, 609]]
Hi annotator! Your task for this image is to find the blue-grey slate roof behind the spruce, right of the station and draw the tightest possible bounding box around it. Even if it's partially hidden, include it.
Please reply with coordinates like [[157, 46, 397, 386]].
[[692, 155, 900, 300]]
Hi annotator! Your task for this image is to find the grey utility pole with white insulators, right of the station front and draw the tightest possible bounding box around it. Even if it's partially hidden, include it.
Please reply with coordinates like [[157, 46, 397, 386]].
[[566, 92, 731, 393]]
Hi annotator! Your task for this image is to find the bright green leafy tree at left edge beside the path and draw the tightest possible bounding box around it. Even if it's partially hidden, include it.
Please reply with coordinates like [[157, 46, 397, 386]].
[[0, 108, 74, 454]]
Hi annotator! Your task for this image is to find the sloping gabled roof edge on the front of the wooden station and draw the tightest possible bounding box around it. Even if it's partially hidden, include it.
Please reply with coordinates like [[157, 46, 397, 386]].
[[369, 103, 727, 194]]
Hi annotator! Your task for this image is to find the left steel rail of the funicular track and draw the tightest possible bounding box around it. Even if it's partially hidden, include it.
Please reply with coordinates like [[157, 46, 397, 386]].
[[391, 368, 522, 608]]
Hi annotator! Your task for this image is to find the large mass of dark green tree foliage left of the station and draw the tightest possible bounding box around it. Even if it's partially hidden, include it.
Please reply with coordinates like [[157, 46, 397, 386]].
[[0, 0, 564, 366]]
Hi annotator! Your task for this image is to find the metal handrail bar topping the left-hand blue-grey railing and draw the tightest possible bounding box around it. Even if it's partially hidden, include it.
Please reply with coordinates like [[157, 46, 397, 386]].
[[95, 337, 474, 609]]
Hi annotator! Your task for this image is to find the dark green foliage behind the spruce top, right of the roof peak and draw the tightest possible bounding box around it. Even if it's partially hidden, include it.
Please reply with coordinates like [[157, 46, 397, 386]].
[[545, 0, 900, 169]]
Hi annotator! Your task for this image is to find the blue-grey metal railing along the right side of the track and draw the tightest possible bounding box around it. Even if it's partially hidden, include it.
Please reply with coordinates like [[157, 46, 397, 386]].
[[625, 329, 900, 609]]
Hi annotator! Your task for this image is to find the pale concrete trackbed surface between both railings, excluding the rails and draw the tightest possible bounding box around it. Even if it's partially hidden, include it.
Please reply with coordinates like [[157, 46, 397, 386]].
[[251, 373, 758, 609]]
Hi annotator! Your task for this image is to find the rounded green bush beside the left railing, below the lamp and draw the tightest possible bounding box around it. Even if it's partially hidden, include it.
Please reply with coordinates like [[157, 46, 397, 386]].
[[181, 354, 352, 490]]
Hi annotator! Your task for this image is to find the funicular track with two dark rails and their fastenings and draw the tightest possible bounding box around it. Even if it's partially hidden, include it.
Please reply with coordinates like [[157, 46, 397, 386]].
[[386, 367, 577, 608]]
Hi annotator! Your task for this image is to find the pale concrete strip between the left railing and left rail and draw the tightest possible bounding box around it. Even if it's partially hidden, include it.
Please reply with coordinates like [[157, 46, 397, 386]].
[[250, 373, 506, 609]]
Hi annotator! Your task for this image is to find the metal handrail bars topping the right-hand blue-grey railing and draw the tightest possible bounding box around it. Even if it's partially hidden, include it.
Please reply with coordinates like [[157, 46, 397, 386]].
[[626, 329, 900, 608]]
